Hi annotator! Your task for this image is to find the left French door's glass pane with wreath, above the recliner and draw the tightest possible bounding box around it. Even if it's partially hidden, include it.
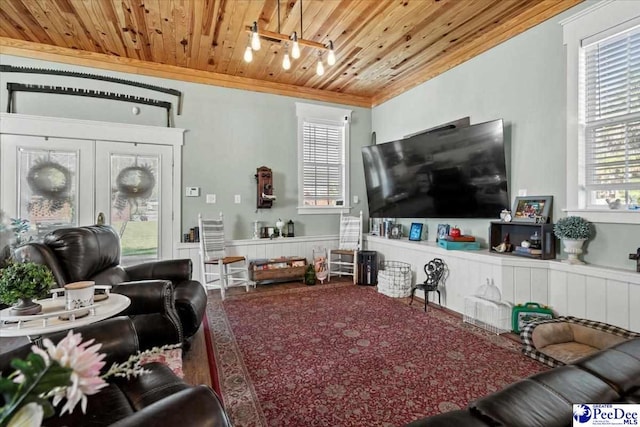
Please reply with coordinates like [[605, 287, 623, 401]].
[[18, 148, 78, 237]]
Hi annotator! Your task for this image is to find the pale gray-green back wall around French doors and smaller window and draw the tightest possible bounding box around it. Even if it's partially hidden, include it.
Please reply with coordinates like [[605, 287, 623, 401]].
[[0, 55, 371, 239]]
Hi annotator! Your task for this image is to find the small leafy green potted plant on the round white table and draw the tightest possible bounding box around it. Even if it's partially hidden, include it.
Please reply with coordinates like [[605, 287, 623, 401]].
[[0, 262, 55, 315]]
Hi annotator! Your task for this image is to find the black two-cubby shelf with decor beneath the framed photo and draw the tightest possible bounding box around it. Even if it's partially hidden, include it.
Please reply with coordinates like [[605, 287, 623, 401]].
[[489, 221, 556, 259]]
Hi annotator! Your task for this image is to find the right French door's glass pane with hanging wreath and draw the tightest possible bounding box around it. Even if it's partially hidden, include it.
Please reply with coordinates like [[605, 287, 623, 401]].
[[110, 154, 160, 265]]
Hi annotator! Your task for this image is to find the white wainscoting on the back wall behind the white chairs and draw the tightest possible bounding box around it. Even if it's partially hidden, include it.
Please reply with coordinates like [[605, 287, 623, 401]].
[[174, 235, 338, 281]]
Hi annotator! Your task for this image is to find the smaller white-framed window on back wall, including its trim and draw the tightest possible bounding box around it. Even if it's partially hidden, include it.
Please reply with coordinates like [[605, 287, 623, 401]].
[[296, 103, 351, 214]]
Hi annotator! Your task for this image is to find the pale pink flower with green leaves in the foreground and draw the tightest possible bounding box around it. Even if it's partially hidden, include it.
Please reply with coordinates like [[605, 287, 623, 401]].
[[0, 331, 179, 427]]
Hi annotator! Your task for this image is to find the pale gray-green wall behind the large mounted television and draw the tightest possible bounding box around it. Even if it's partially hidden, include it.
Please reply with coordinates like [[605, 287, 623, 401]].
[[372, 2, 640, 270]]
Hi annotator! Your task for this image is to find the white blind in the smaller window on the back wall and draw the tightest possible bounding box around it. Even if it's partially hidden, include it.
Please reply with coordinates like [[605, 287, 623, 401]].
[[302, 120, 345, 206]]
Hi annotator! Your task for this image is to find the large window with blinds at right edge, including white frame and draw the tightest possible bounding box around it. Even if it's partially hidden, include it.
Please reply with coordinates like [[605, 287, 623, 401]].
[[562, 1, 640, 223]]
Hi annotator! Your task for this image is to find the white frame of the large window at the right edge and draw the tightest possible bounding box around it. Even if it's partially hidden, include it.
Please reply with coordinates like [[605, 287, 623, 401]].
[[560, 1, 640, 224]]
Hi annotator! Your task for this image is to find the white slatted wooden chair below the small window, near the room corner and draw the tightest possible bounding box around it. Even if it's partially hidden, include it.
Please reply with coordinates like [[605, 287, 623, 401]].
[[328, 211, 362, 283]]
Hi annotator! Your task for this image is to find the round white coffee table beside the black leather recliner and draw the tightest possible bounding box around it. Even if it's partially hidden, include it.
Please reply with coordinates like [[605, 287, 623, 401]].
[[0, 293, 131, 341]]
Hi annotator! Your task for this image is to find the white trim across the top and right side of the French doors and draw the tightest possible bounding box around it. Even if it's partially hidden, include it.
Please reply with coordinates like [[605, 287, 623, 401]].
[[0, 113, 185, 258]]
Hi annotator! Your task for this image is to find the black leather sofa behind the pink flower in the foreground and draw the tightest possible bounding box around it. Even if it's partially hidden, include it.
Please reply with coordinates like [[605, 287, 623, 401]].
[[0, 316, 231, 427]]
